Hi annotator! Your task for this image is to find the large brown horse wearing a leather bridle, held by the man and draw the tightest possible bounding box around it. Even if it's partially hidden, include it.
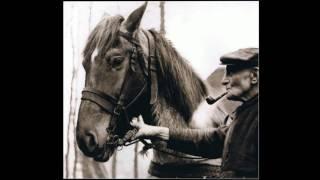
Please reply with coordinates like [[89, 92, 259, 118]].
[[76, 2, 236, 177]]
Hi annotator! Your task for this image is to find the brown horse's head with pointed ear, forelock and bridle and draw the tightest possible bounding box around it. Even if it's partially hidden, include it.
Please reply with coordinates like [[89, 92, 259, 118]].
[[76, 2, 152, 162]]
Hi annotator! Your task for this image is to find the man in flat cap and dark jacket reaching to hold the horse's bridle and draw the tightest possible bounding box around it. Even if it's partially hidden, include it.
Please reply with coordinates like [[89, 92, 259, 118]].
[[131, 48, 259, 178]]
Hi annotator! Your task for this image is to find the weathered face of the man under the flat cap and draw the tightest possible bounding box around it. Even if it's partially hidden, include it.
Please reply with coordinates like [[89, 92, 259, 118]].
[[222, 65, 256, 101]]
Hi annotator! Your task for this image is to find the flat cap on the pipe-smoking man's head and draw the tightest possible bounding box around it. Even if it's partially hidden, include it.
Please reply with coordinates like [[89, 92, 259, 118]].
[[220, 48, 259, 66]]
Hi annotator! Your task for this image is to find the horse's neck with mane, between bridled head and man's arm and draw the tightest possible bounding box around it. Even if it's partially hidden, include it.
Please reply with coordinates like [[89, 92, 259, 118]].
[[142, 32, 212, 163]]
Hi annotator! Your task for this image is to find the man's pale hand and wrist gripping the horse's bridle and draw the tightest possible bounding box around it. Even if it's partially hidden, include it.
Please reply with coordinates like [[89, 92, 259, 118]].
[[130, 115, 169, 140]]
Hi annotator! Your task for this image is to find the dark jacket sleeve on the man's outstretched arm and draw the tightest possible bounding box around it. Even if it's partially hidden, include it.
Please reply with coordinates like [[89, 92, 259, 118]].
[[167, 126, 229, 158]]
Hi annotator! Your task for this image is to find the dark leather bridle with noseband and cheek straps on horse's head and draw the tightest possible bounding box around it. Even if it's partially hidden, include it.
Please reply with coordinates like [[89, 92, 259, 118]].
[[81, 31, 157, 147]]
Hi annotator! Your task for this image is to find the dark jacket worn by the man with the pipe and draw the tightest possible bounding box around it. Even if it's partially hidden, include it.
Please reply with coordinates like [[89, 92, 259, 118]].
[[168, 95, 258, 177]]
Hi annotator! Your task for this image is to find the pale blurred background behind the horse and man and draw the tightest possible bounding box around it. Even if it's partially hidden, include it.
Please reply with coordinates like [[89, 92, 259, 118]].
[[63, 1, 259, 178]]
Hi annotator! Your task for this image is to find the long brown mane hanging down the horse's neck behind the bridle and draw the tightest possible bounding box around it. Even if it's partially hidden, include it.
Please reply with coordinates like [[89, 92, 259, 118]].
[[150, 30, 208, 124]]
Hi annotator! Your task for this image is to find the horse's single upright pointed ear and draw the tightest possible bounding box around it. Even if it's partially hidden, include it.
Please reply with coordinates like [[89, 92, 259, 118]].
[[123, 1, 148, 33]]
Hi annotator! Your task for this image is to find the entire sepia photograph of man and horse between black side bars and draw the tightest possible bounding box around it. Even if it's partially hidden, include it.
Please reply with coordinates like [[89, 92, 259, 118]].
[[63, 1, 260, 179]]
